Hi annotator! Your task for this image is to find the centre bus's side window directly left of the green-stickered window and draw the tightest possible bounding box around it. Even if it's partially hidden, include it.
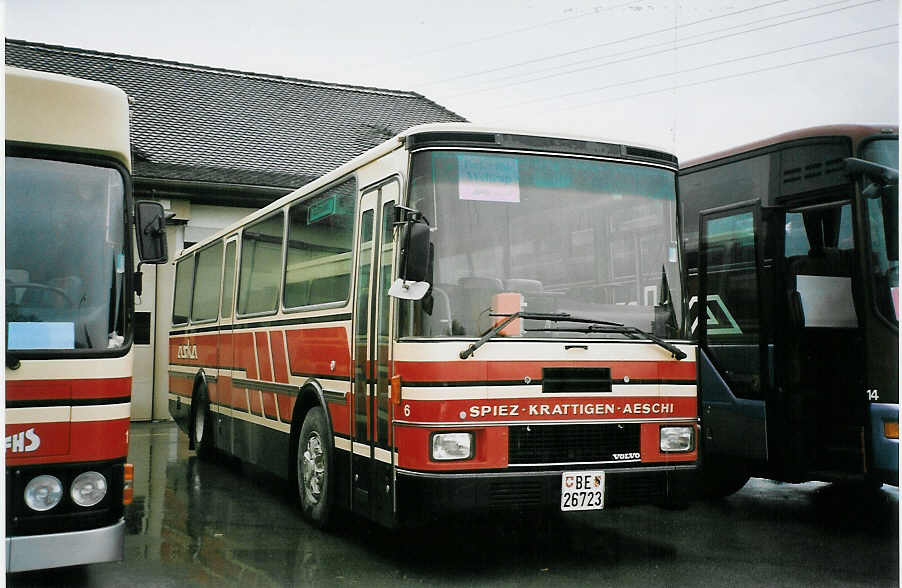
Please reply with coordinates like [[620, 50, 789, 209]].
[[238, 211, 285, 315]]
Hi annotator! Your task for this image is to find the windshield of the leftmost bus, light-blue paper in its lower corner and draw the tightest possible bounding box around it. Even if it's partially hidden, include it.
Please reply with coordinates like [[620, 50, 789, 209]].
[[6, 157, 125, 353]]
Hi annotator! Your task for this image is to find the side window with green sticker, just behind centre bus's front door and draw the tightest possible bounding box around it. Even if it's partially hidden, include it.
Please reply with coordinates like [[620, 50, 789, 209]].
[[283, 178, 357, 308]]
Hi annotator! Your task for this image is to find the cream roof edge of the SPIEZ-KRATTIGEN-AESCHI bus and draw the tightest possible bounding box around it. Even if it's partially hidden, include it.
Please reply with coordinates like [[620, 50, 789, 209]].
[[175, 123, 677, 257]]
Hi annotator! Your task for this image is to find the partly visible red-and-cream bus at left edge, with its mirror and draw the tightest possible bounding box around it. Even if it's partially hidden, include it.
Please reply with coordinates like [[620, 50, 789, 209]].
[[5, 68, 165, 572]]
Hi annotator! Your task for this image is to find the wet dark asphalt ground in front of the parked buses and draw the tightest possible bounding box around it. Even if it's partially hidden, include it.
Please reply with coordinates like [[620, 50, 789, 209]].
[[7, 423, 899, 586]]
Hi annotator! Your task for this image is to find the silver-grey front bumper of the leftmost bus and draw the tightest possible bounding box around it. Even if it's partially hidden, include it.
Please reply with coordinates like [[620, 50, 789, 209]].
[[6, 519, 125, 572]]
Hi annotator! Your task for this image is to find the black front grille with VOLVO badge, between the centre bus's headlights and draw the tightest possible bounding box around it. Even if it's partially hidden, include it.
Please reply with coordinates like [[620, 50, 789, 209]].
[[508, 423, 639, 465]]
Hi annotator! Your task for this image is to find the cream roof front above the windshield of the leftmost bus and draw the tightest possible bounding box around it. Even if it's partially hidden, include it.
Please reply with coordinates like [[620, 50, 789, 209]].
[[6, 67, 131, 170]]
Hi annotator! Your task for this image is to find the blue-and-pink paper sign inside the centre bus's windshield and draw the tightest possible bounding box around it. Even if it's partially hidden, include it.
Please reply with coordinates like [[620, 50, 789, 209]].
[[457, 155, 520, 202]]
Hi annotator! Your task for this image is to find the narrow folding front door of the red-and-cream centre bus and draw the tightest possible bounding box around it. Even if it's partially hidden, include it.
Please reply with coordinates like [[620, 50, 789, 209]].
[[351, 180, 399, 525]]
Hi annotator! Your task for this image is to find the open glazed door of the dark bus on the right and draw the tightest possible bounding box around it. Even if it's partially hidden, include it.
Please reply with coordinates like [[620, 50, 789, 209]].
[[696, 201, 770, 463]]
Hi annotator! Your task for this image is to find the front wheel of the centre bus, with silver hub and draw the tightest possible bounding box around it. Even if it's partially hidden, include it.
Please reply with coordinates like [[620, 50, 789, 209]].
[[296, 407, 332, 529]]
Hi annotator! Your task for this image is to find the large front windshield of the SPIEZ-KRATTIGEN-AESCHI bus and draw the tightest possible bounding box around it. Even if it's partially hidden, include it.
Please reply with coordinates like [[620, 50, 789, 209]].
[[400, 151, 681, 338]]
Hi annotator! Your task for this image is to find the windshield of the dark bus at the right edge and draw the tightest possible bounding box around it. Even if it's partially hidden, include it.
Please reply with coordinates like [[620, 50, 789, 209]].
[[861, 138, 899, 323]]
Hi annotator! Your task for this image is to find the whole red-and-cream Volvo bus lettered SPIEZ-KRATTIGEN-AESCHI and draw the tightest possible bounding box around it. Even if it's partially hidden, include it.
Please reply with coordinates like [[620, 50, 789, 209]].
[[169, 124, 698, 525]]
